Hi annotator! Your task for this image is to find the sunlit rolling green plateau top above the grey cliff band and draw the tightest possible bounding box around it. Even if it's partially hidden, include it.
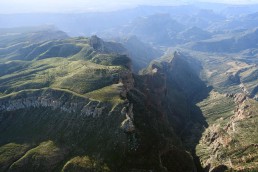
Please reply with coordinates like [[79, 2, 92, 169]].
[[0, 33, 130, 104]]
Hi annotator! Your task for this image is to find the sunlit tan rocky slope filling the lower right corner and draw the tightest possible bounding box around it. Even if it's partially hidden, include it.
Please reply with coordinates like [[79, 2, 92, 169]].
[[198, 93, 258, 172]]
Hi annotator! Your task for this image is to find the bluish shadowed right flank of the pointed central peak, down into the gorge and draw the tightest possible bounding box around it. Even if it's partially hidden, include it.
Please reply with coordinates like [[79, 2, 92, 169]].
[[139, 51, 212, 171]]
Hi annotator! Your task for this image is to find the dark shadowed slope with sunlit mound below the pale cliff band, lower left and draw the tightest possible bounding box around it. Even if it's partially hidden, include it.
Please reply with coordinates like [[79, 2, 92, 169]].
[[0, 105, 126, 171]]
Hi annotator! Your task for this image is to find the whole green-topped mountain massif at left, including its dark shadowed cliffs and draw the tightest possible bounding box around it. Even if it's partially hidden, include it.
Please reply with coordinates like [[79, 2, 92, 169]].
[[0, 28, 204, 172]]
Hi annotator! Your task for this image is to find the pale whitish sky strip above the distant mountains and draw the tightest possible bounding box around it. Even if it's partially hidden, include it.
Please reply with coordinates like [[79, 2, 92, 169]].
[[0, 0, 258, 13]]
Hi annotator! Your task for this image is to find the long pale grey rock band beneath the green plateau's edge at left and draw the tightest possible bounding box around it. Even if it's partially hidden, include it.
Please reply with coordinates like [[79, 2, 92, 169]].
[[0, 90, 108, 117]]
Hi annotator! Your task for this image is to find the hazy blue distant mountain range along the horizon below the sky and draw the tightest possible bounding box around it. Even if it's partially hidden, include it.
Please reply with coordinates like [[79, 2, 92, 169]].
[[0, 3, 258, 36]]
